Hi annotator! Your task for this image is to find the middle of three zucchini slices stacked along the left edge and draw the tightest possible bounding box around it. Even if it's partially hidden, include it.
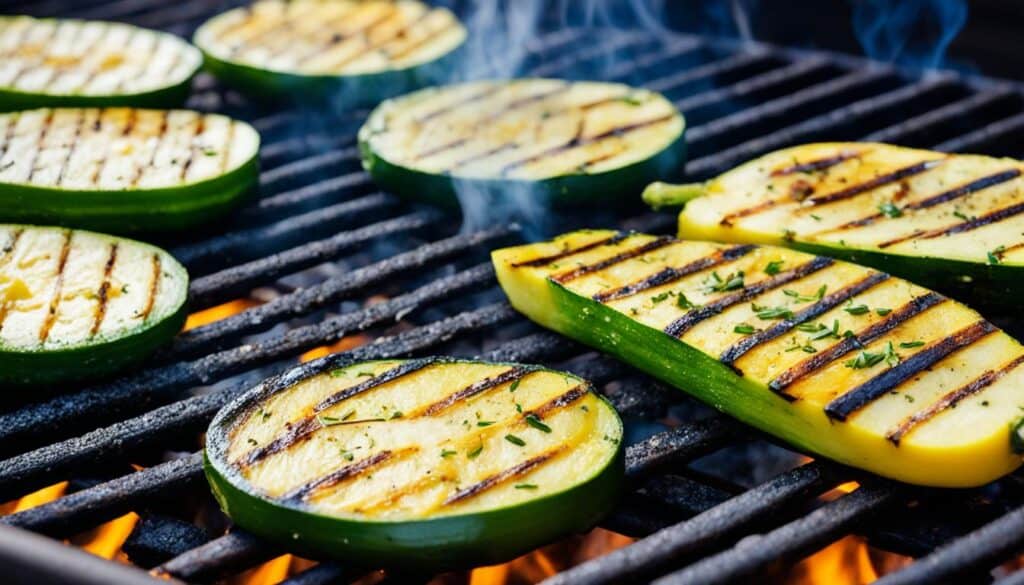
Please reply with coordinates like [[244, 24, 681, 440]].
[[0, 108, 259, 233]]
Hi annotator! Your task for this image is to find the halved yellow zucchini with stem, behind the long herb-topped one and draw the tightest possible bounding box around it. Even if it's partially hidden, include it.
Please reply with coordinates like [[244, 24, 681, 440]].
[[644, 142, 1024, 304]]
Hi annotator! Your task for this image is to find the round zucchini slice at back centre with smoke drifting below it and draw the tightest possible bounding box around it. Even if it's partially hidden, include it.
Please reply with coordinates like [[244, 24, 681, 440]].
[[359, 79, 686, 206]]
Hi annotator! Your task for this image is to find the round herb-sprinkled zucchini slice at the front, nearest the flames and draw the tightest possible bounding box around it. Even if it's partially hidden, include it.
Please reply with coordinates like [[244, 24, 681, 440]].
[[206, 357, 625, 571]]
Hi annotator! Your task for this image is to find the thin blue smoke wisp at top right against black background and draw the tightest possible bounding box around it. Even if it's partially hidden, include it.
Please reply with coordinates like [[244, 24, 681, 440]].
[[853, 0, 968, 70]]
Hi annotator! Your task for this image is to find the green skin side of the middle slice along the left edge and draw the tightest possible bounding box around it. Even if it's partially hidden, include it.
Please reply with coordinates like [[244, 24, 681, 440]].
[[0, 155, 259, 235]]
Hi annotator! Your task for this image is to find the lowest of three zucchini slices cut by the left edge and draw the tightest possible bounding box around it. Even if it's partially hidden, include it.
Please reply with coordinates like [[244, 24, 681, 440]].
[[0, 224, 188, 386]]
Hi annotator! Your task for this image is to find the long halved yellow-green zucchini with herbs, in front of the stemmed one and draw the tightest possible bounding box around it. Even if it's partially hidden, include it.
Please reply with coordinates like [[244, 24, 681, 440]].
[[494, 232, 1024, 487]]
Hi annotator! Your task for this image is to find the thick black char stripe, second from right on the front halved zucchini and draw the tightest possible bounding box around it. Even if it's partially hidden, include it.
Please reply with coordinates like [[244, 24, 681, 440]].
[[825, 321, 997, 421]]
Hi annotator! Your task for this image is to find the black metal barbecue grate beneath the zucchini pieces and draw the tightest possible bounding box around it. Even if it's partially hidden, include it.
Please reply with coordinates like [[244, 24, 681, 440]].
[[0, 0, 1024, 585]]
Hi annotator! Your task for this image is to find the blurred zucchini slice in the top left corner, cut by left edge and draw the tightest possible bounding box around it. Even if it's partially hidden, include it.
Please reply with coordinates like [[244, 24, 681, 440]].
[[0, 16, 203, 111]]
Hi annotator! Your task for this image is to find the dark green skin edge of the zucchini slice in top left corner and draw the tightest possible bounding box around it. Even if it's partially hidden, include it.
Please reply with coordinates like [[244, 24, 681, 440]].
[[0, 81, 195, 112]]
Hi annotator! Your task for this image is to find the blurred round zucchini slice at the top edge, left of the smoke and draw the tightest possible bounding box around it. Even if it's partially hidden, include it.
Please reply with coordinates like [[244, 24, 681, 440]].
[[194, 0, 466, 103]]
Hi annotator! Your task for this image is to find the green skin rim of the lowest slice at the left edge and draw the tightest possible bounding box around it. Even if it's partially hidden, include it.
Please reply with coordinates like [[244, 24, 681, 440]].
[[0, 225, 188, 389]]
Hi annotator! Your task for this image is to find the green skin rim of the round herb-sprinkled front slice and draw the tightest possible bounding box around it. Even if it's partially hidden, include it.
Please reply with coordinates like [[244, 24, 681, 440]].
[[204, 354, 626, 572]]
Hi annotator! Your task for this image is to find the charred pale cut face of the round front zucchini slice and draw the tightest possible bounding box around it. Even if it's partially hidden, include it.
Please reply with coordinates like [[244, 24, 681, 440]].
[[226, 359, 621, 519]]
